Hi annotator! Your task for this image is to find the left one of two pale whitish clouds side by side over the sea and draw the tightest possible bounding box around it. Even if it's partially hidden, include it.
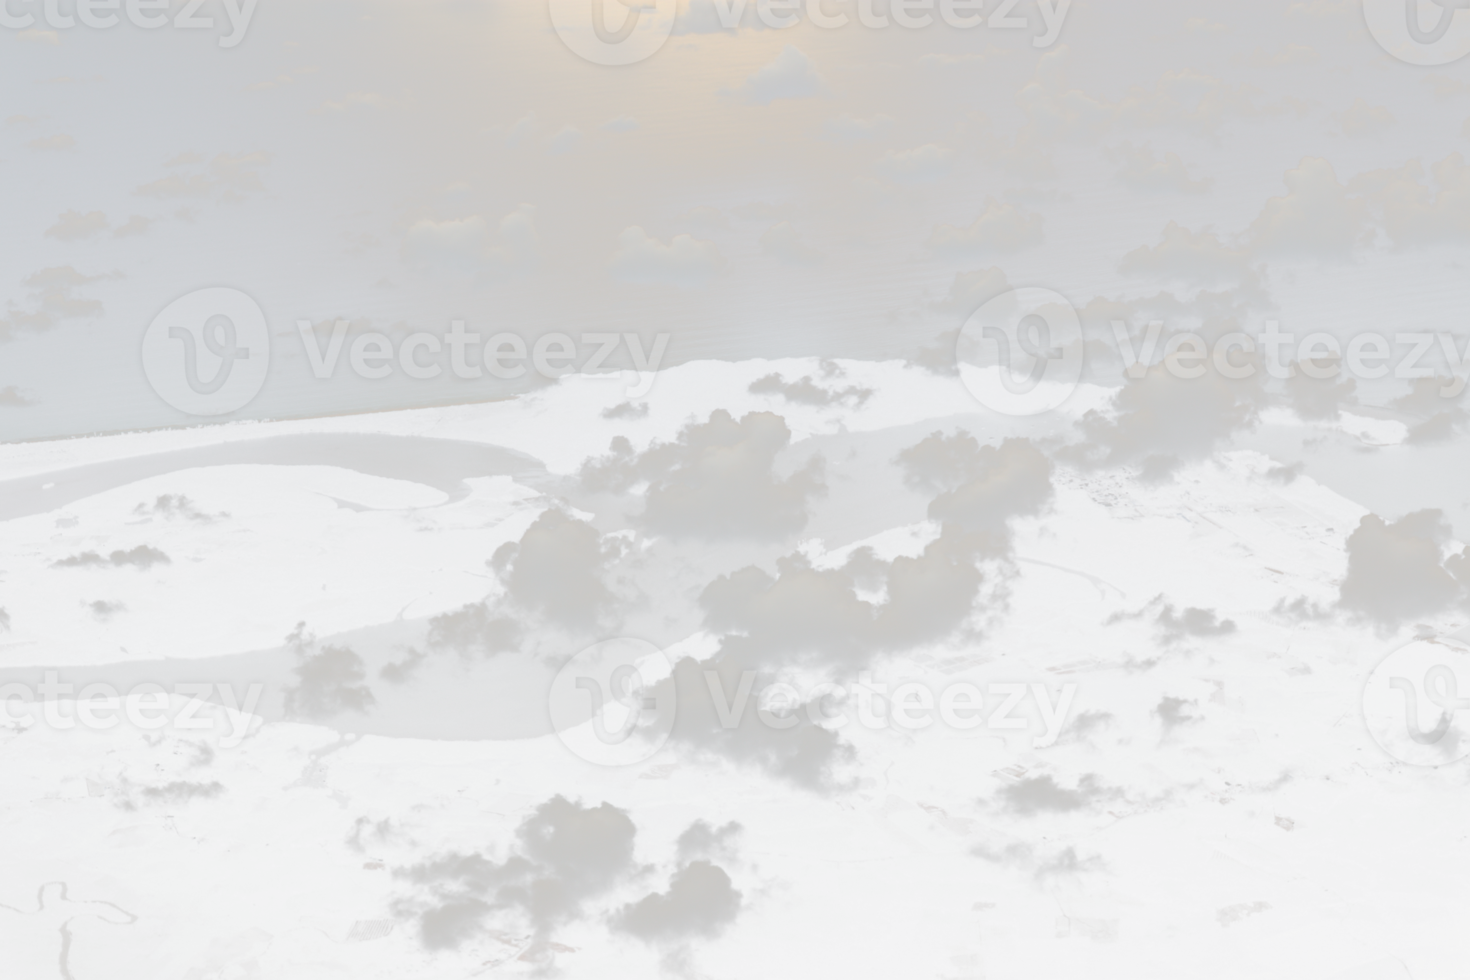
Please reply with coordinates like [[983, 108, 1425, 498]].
[[392, 203, 556, 292]]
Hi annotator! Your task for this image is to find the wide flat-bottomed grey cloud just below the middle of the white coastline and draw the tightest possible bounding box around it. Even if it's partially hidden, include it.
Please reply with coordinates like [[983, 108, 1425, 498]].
[[579, 408, 826, 544]]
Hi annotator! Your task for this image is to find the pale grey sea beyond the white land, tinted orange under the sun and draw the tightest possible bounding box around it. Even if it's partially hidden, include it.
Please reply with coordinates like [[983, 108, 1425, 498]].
[[0, 0, 1470, 439]]
